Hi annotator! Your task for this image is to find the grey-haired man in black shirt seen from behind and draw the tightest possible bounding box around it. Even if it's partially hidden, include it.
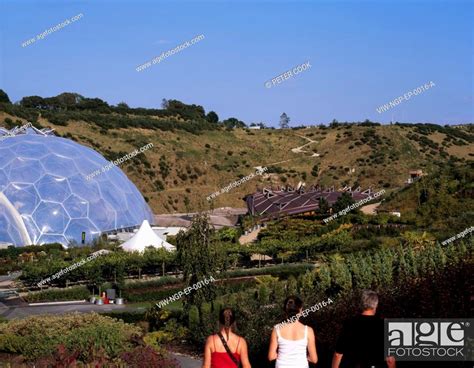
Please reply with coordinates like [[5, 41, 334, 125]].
[[332, 290, 395, 368]]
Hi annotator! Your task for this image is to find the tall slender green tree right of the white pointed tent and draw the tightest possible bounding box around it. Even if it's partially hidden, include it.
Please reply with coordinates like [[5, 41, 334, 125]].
[[176, 214, 217, 322]]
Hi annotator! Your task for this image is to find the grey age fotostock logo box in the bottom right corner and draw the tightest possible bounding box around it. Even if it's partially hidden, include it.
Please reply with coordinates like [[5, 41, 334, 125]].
[[385, 318, 474, 361]]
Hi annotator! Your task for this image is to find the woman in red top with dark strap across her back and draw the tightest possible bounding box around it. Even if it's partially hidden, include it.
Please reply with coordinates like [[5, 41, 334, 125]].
[[202, 308, 251, 368]]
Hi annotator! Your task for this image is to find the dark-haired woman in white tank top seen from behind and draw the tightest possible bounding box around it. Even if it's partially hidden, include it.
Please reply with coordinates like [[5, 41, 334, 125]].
[[268, 296, 318, 368]]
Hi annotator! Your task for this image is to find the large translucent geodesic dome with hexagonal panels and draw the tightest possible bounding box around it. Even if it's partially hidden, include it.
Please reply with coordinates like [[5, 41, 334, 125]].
[[0, 128, 154, 246]]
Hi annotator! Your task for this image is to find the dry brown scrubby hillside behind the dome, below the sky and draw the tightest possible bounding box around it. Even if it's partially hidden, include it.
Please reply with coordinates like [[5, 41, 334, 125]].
[[0, 93, 474, 213]]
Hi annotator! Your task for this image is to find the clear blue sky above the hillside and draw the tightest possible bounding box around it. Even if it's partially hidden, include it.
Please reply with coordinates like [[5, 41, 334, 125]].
[[0, 0, 474, 126]]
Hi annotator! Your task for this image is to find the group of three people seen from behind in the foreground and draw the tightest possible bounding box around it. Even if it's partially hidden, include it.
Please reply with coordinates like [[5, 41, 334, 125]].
[[202, 290, 396, 368]]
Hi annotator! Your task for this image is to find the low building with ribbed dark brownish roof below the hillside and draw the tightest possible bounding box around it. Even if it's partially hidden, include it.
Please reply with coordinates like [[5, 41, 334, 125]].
[[244, 186, 372, 220]]
